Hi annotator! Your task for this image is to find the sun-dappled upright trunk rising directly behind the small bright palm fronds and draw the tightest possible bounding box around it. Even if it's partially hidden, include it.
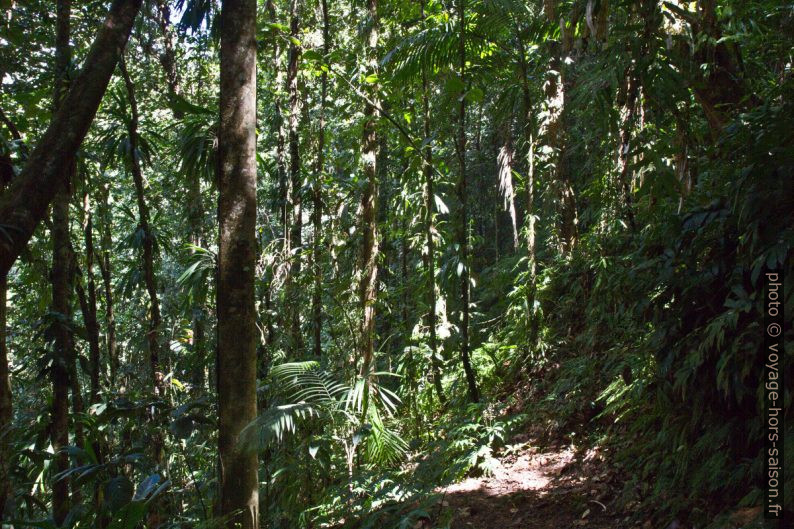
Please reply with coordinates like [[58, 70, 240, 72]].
[[358, 0, 379, 417]]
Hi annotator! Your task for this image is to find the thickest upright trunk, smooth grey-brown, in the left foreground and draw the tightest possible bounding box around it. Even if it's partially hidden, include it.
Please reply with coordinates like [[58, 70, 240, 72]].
[[217, 0, 259, 529]]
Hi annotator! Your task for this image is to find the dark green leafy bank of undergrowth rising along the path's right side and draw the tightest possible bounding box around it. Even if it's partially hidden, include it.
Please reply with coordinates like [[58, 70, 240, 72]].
[[332, 97, 794, 527]]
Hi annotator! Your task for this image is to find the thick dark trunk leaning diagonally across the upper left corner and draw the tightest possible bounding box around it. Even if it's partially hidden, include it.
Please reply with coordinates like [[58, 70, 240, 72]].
[[0, 0, 142, 277]]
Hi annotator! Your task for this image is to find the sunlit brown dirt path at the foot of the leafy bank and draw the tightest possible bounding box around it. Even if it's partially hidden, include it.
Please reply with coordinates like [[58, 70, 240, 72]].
[[440, 447, 624, 529]]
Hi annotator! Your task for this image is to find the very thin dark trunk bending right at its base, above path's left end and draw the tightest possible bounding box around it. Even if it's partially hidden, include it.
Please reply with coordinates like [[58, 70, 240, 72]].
[[457, 0, 480, 402]]
